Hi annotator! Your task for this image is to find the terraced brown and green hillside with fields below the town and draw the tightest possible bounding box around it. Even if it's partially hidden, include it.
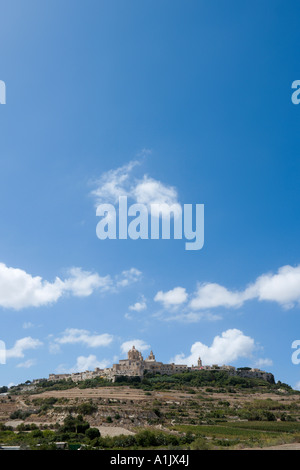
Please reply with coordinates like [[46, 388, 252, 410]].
[[0, 372, 300, 449]]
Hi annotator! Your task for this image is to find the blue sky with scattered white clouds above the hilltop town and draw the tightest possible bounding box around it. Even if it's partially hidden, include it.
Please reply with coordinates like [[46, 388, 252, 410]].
[[0, 0, 300, 387]]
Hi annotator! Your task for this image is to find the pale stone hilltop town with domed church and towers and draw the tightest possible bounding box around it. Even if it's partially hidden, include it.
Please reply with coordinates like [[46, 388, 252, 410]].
[[48, 346, 274, 383]]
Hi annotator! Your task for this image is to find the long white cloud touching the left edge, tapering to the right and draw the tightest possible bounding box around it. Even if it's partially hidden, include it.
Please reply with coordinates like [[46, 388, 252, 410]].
[[0, 263, 141, 310]]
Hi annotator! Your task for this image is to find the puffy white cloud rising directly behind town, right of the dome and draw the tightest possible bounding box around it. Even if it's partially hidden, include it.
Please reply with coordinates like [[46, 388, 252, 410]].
[[172, 329, 255, 366]]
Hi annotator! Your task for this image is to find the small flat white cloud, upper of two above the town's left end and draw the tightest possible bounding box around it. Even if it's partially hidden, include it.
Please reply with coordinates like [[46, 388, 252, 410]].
[[54, 328, 113, 348]]
